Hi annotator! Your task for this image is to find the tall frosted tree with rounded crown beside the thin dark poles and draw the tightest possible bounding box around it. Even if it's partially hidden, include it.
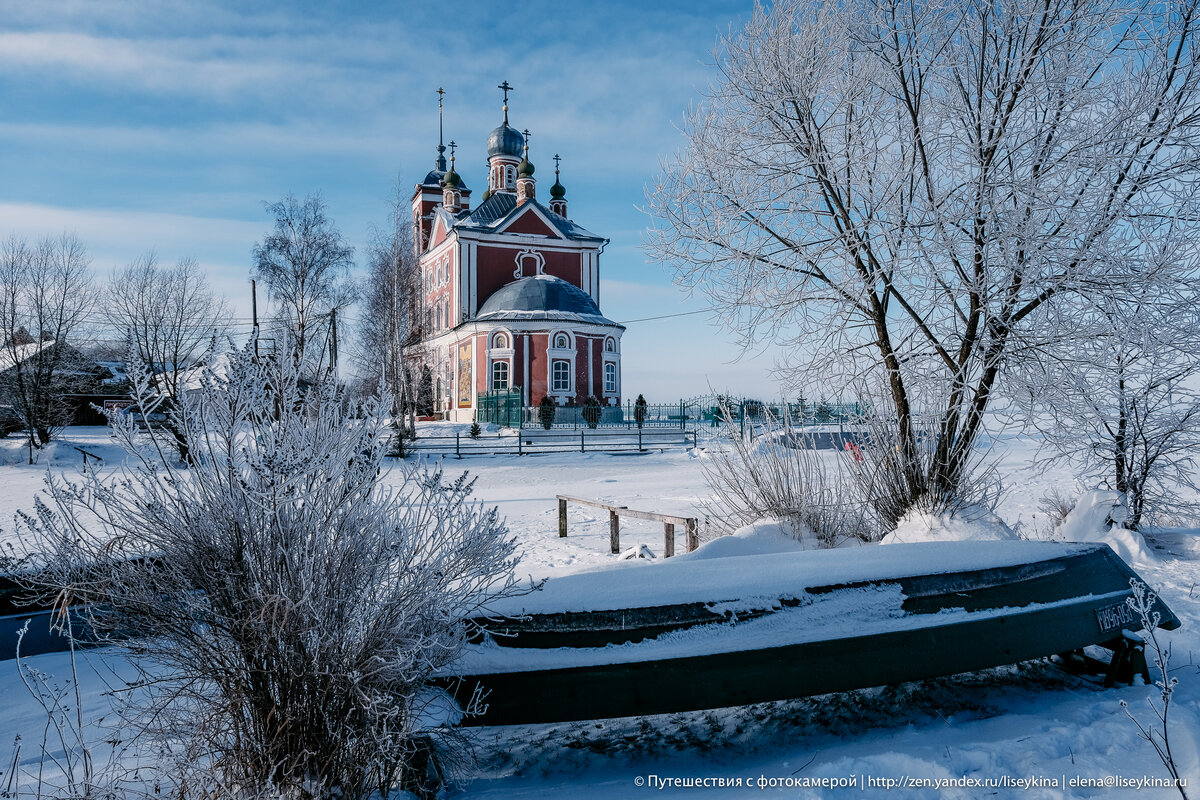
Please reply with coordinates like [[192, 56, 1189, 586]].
[[253, 193, 355, 378]]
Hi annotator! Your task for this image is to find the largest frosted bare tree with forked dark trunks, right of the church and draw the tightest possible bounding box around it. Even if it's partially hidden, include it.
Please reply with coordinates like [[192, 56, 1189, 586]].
[[648, 0, 1200, 525]]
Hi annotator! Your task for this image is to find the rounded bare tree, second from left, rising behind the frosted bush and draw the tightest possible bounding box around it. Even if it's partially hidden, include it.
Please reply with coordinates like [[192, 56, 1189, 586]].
[[104, 252, 227, 461]]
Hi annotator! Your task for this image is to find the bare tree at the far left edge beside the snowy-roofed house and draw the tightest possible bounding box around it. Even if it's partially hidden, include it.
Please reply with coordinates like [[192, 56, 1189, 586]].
[[0, 234, 94, 447]]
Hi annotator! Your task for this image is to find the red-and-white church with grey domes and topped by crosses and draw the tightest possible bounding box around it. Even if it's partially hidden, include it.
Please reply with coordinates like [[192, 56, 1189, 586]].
[[406, 82, 625, 422]]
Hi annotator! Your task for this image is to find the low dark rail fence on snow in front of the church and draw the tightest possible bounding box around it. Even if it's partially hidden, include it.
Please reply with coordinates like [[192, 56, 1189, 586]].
[[404, 427, 697, 458]]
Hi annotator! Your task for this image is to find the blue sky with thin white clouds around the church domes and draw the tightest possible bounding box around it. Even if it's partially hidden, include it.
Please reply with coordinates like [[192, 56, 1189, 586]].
[[0, 0, 779, 401]]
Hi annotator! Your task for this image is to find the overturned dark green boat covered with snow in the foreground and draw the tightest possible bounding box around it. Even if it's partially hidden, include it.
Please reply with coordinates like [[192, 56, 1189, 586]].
[[439, 541, 1180, 726]]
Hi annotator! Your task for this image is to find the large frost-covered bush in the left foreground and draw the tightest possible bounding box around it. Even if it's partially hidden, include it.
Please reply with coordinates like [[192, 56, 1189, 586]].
[[24, 347, 515, 798]]
